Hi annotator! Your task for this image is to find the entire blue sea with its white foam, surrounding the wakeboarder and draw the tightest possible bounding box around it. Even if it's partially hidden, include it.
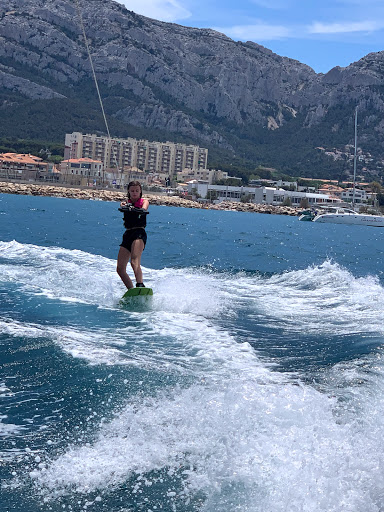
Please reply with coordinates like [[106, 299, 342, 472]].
[[0, 195, 384, 512]]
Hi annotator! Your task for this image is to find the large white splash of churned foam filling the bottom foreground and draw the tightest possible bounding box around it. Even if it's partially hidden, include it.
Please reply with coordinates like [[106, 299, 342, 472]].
[[30, 356, 384, 512]]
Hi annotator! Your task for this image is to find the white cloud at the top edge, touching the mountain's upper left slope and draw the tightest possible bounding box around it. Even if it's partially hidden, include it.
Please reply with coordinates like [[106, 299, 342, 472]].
[[120, 0, 191, 22]]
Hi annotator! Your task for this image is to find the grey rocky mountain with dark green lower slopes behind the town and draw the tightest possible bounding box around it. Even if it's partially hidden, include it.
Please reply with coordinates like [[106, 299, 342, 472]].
[[0, 0, 384, 180]]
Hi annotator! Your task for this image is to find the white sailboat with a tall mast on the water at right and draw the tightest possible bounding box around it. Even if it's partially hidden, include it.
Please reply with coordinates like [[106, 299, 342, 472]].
[[312, 108, 384, 228]]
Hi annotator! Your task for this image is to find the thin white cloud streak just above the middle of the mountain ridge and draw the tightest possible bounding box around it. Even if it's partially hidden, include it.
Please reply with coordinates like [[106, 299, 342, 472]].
[[214, 23, 292, 41]]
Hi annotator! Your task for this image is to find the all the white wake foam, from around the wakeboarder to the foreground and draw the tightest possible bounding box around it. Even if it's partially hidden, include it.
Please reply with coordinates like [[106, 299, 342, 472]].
[[0, 242, 384, 512]]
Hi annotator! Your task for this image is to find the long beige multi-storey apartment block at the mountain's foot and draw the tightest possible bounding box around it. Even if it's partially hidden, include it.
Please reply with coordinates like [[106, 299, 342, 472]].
[[64, 132, 208, 176]]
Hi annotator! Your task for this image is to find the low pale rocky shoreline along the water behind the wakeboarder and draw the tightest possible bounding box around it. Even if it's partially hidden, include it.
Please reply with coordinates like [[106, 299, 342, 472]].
[[0, 181, 299, 215]]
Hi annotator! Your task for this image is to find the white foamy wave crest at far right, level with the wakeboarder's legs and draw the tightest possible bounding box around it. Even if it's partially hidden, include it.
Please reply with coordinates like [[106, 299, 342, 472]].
[[232, 261, 384, 335]]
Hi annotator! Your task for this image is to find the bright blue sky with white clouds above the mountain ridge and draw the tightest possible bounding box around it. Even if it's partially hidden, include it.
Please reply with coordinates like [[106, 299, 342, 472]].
[[120, 0, 384, 73]]
